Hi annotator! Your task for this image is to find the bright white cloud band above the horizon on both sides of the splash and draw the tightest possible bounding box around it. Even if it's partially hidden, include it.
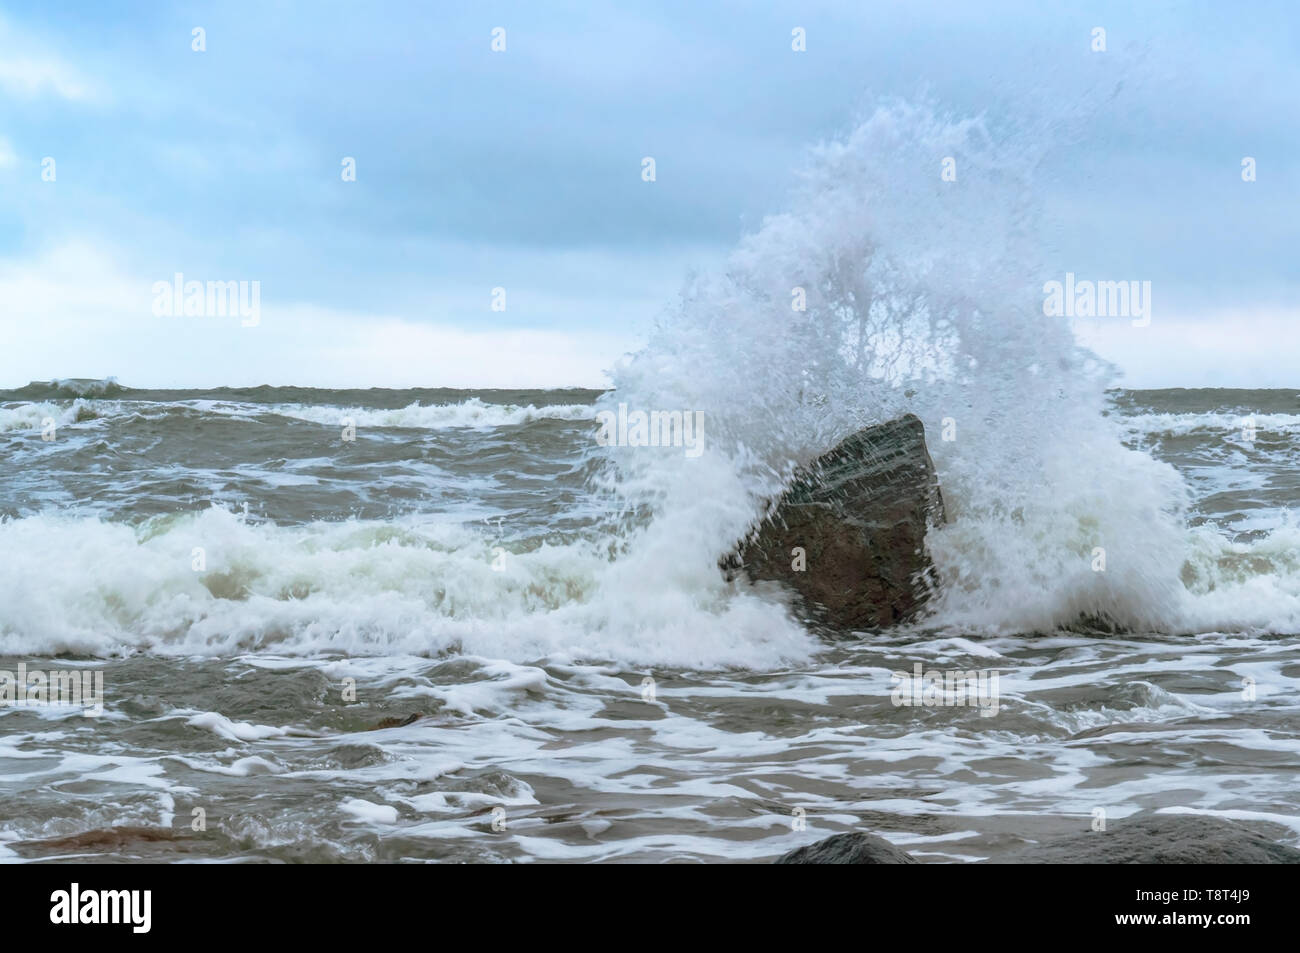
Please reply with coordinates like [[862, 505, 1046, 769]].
[[10, 242, 1300, 387]]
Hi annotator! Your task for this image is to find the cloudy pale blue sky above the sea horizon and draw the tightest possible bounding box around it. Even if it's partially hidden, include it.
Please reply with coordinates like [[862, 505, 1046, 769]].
[[0, 0, 1300, 387]]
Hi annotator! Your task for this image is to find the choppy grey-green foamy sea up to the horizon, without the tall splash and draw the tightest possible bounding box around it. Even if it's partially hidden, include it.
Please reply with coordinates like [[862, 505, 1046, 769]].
[[0, 385, 1300, 861]]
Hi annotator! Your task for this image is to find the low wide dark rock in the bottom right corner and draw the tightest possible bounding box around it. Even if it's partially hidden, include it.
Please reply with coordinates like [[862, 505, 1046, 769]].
[[985, 814, 1300, 863]]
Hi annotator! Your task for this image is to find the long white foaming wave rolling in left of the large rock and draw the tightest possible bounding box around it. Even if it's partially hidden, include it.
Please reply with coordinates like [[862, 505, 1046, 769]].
[[0, 508, 816, 668]]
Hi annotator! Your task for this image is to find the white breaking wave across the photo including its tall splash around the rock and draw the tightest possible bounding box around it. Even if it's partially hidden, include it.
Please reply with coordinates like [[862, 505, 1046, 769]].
[[0, 104, 1300, 668]]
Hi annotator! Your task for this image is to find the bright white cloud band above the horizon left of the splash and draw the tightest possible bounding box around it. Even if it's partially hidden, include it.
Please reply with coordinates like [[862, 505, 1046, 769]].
[[0, 243, 636, 387]]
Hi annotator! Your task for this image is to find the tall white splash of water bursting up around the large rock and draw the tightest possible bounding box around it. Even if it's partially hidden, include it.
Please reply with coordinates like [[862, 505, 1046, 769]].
[[607, 98, 1187, 631]]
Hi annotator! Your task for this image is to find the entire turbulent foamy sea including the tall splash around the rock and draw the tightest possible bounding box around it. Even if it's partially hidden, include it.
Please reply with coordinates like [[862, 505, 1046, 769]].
[[0, 105, 1300, 861]]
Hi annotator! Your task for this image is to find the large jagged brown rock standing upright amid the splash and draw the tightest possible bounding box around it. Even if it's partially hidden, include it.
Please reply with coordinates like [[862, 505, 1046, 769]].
[[723, 413, 944, 629]]
